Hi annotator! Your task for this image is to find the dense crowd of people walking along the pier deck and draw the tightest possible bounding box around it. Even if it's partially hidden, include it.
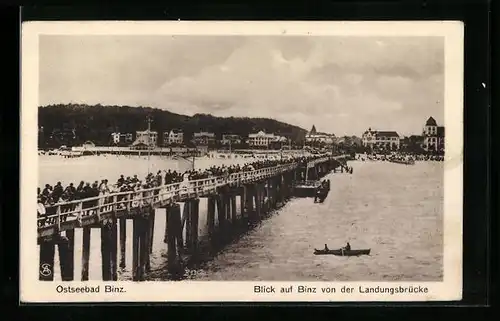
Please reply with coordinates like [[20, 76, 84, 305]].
[[37, 155, 328, 219]]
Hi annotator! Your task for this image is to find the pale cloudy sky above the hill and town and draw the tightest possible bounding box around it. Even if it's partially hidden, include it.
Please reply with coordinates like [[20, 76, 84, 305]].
[[39, 35, 444, 136]]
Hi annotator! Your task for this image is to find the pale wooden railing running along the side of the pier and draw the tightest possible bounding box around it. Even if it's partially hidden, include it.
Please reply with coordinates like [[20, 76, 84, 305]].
[[38, 156, 337, 237]]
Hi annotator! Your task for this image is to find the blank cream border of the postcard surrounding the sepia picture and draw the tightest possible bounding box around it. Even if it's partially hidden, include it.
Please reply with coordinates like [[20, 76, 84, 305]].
[[19, 21, 464, 302]]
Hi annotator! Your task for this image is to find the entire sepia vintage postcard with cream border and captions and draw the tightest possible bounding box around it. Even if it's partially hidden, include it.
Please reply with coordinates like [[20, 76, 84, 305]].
[[20, 21, 463, 302]]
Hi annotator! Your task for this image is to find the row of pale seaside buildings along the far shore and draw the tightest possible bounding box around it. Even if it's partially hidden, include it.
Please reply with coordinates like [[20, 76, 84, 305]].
[[41, 117, 444, 152]]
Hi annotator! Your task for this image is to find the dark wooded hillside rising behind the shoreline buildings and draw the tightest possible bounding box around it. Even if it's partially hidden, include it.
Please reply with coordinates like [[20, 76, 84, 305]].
[[38, 104, 306, 147]]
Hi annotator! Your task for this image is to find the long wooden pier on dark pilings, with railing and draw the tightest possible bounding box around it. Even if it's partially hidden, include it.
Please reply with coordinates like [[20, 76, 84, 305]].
[[38, 156, 345, 281]]
